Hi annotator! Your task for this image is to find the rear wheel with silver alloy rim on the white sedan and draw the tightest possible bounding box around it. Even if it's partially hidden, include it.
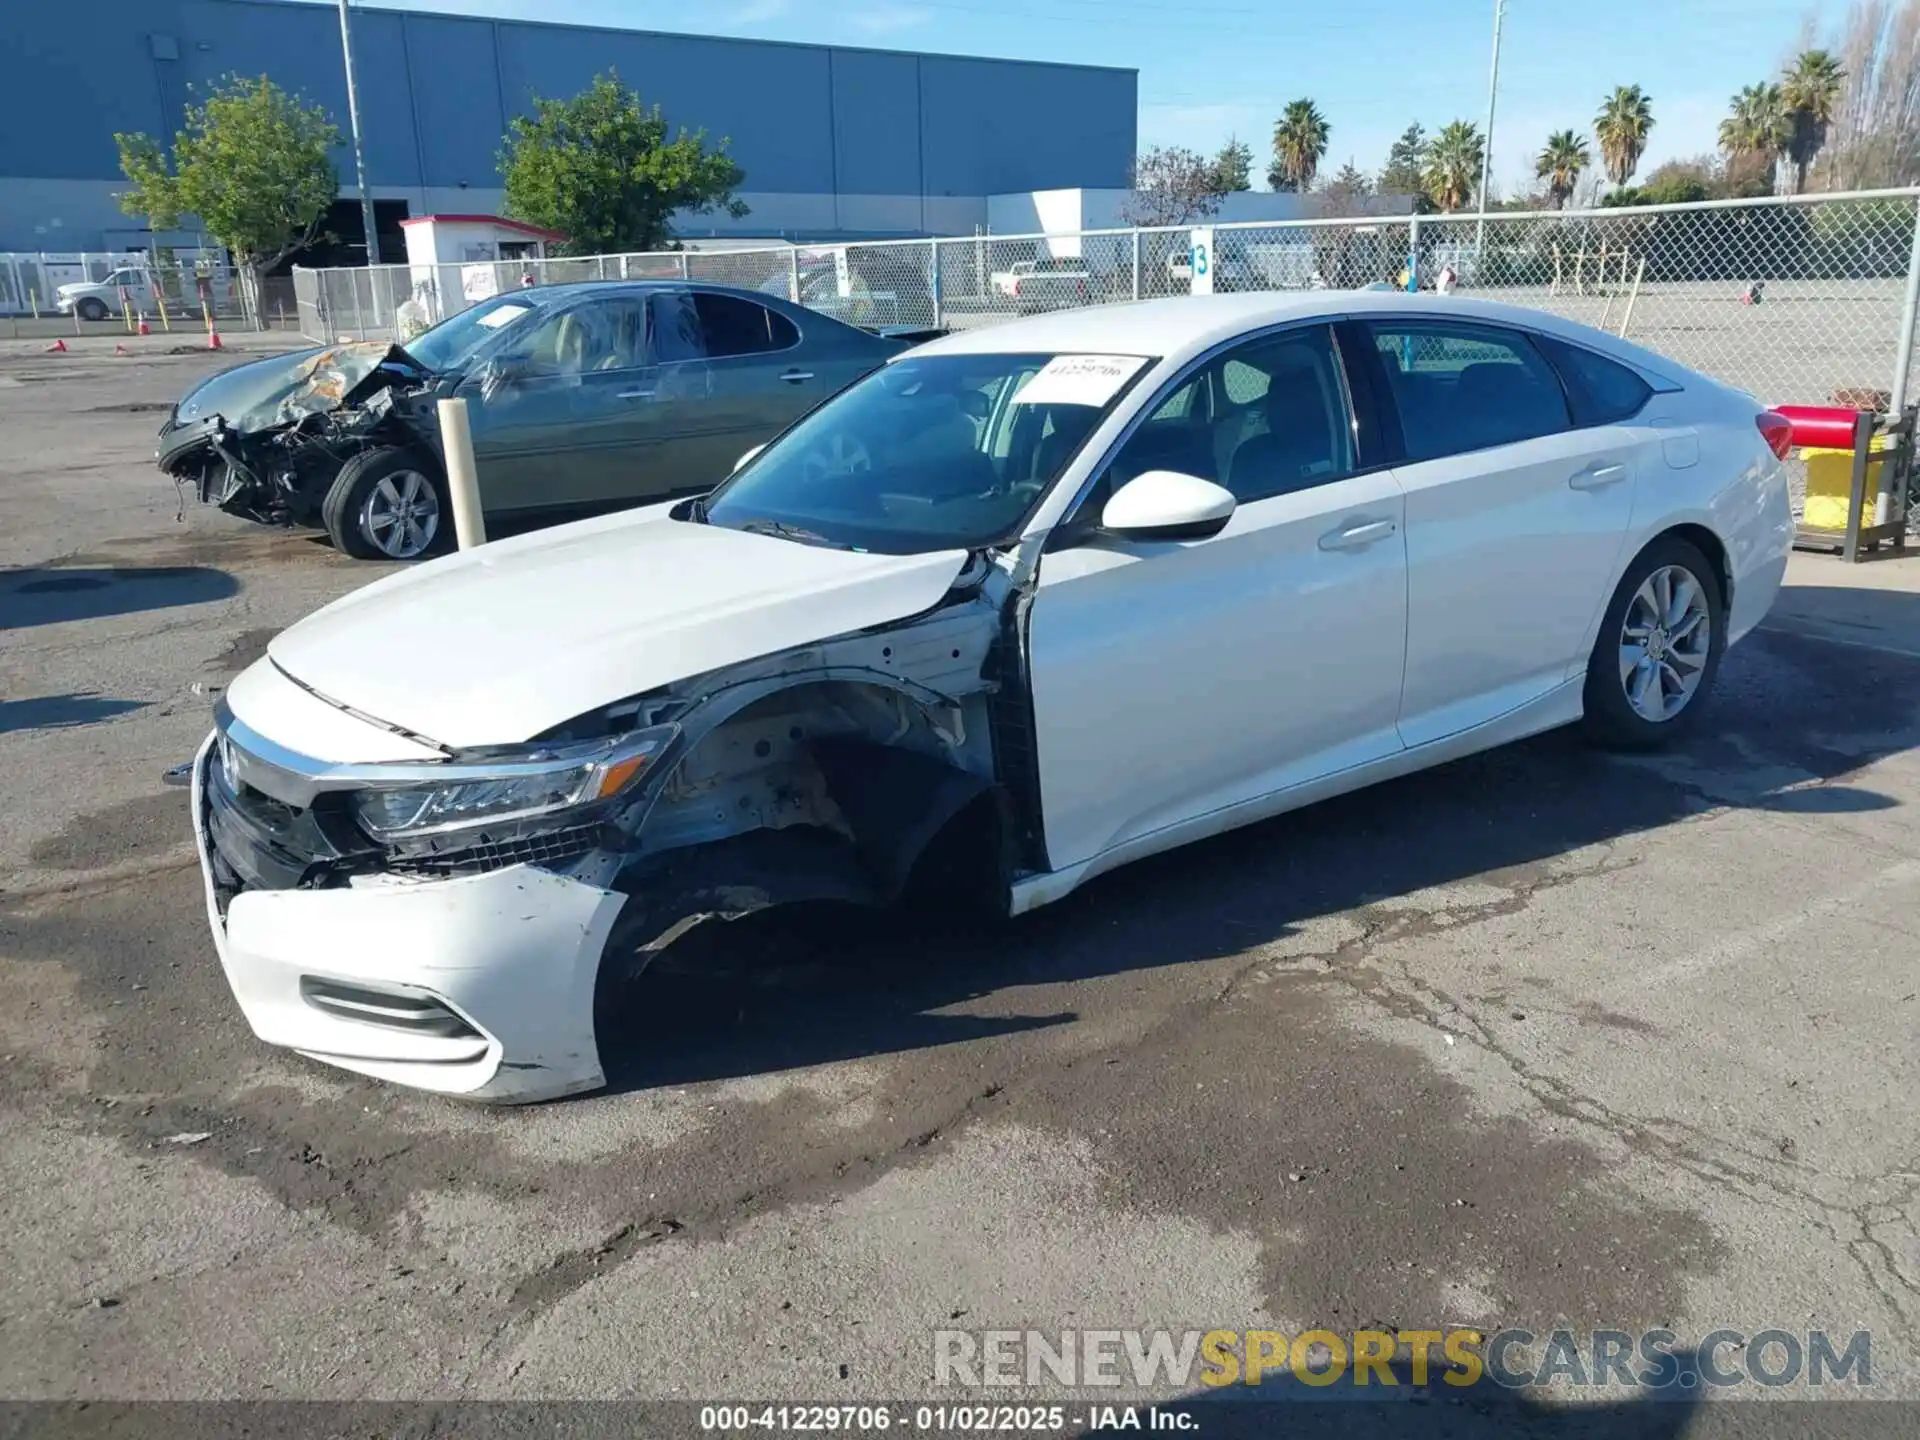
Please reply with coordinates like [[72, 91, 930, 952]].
[[1584, 536, 1726, 751]]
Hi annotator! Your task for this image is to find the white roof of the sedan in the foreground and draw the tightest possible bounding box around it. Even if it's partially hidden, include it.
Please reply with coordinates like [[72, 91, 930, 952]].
[[910, 290, 1686, 378]]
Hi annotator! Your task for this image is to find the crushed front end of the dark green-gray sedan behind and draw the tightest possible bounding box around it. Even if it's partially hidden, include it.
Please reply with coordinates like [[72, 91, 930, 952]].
[[154, 342, 438, 524]]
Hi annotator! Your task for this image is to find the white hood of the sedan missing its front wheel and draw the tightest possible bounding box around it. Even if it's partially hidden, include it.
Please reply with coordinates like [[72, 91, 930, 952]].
[[267, 505, 966, 751]]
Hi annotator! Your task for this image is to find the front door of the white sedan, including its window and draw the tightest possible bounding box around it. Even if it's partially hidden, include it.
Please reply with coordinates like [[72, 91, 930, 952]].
[[1029, 324, 1407, 870]]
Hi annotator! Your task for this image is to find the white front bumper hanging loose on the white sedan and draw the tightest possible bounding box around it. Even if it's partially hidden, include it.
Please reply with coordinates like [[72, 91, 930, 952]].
[[192, 735, 626, 1102]]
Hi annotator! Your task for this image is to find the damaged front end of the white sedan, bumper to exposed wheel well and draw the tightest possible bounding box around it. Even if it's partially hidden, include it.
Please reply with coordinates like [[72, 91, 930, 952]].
[[194, 553, 1044, 1102]]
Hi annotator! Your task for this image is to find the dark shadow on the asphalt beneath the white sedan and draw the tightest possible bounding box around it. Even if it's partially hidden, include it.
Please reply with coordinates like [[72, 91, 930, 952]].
[[603, 634, 1920, 1089]]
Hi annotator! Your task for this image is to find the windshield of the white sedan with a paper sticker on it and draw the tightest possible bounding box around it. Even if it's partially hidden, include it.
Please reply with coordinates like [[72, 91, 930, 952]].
[[705, 355, 1150, 555]]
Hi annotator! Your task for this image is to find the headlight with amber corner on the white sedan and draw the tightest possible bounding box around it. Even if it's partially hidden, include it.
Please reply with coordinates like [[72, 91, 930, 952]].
[[353, 726, 680, 841]]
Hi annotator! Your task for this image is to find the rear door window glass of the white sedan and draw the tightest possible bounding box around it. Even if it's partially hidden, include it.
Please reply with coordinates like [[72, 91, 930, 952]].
[[1369, 321, 1572, 461]]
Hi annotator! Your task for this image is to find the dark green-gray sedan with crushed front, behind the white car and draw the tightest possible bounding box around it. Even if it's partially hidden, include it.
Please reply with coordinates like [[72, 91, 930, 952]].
[[156, 282, 906, 561]]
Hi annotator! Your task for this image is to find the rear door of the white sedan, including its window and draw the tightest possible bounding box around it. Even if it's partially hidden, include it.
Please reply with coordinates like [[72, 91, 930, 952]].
[[1348, 319, 1642, 747]]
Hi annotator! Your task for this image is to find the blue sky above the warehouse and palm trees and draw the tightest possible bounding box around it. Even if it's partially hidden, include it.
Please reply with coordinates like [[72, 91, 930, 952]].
[[330, 0, 1841, 192]]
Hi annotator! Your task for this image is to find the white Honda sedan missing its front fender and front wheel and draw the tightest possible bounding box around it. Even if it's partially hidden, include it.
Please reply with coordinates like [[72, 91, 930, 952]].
[[194, 292, 1791, 1100]]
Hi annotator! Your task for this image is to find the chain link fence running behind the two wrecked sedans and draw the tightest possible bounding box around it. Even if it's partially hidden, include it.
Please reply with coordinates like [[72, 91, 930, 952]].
[[284, 190, 1920, 409]]
